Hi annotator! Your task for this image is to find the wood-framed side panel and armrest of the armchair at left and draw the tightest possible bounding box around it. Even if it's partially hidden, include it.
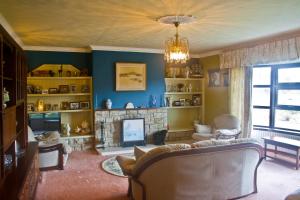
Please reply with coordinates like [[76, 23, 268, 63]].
[[39, 143, 64, 171]]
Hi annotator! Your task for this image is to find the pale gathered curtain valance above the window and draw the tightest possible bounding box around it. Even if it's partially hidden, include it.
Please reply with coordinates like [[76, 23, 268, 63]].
[[220, 36, 300, 69]]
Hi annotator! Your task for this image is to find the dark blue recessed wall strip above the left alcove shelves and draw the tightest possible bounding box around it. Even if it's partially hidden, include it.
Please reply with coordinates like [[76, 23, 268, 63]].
[[25, 51, 92, 74]]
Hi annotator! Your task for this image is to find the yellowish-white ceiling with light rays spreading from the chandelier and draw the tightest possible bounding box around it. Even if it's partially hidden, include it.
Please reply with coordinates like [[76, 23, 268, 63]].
[[0, 0, 300, 53]]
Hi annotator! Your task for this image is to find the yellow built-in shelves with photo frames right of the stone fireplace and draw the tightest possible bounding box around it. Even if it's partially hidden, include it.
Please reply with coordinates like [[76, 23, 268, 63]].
[[165, 78, 205, 132]]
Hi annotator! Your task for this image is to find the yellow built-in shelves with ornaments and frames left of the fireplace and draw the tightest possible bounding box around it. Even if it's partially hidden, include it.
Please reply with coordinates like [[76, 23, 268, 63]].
[[27, 65, 94, 137]]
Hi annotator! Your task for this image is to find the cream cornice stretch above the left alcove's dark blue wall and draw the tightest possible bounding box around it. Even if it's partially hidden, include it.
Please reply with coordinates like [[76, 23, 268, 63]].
[[23, 46, 91, 53]]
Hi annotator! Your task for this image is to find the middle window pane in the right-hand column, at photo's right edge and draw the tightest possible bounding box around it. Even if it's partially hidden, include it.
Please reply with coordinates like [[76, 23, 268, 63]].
[[277, 90, 300, 106]]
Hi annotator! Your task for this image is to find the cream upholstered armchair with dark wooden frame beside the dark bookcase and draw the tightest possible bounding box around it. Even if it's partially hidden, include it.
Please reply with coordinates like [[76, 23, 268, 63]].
[[28, 126, 71, 171]]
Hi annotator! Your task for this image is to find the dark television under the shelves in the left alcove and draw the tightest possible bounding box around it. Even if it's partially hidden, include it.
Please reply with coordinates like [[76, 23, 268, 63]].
[[28, 112, 61, 134]]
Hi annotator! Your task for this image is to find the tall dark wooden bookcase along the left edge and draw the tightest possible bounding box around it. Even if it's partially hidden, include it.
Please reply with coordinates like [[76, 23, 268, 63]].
[[0, 26, 39, 199]]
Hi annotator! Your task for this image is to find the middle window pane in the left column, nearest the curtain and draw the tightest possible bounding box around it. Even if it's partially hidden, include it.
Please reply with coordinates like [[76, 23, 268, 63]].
[[252, 88, 270, 106]]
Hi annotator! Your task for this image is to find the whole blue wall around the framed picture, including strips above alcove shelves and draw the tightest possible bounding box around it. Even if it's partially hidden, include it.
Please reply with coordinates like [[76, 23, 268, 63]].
[[26, 51, 199, 109]]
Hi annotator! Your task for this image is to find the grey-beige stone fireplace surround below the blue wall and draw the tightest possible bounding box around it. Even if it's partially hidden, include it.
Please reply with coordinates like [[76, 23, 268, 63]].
[[95, 108, 168, 147]]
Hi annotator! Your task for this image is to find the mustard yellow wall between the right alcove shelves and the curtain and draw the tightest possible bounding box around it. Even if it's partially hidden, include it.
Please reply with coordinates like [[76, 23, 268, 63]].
[[200, 55, 229, 124]]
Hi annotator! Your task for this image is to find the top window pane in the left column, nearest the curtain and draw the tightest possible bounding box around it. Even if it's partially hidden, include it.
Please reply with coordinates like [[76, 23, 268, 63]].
[[252, 67, 271, 85]]
